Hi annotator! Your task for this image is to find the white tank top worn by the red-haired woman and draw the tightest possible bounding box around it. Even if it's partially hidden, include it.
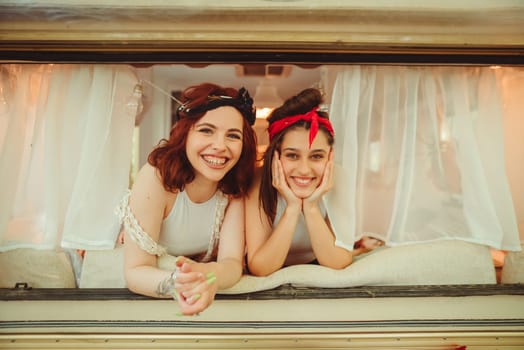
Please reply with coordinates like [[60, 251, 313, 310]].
[[159, 191, 217, 256]]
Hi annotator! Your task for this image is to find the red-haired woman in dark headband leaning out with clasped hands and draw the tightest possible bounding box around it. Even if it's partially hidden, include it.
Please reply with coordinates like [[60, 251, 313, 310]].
[[119, 83, 256, 315]]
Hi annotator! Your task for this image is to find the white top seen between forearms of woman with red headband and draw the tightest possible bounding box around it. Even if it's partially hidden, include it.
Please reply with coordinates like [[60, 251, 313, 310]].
[[273, 196, 326, 266]]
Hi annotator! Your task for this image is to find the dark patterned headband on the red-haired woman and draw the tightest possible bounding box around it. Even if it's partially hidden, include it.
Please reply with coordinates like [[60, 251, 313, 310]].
[[176, 87, 256, 125]]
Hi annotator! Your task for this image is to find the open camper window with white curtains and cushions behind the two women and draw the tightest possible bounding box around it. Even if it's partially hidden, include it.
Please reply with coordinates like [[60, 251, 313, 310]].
[[0, 62, 524, 298]]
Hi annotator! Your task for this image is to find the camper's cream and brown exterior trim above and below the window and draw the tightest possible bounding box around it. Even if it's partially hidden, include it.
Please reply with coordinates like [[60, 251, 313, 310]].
[[0, 4, 524, 348]]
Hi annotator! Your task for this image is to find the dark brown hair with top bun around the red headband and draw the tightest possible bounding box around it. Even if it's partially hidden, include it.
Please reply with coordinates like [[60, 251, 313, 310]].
[[259, 88, 334, 223]]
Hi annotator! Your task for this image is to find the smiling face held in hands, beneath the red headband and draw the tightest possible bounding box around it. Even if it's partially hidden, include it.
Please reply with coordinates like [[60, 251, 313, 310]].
[[280, 128, 331, 198]]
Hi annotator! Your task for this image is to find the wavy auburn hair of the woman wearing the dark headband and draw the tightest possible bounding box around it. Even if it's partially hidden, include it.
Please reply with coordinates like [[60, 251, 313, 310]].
[[147, 83, 257, 197]]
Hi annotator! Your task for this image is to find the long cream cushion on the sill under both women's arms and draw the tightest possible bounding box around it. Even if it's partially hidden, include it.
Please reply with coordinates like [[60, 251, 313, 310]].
[[80, 240, 496, 294]]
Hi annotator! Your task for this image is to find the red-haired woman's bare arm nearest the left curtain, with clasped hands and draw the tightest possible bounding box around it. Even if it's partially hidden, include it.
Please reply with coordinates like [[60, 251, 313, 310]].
[[124, 165, 224, 315]]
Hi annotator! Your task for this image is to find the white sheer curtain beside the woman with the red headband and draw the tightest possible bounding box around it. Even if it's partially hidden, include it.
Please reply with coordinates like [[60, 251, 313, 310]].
[[326, 66, 520, 250]]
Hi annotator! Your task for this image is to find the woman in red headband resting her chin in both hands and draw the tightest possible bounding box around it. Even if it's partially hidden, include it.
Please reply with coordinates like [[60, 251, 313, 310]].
[[246, 89, 382, 276]]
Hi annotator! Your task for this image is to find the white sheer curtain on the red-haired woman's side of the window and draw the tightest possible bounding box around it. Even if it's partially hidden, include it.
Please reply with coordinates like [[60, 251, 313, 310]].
[[0, 64, 138, 251]]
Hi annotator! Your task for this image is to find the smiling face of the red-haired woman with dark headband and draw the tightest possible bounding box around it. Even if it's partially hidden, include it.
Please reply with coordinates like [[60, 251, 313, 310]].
[[186, 106, 243, 182]]
